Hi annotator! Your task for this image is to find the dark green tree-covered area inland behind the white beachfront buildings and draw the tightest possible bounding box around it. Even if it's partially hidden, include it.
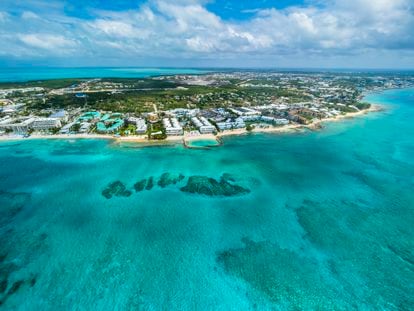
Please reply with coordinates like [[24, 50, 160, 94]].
[[0, 75, 382, 114]]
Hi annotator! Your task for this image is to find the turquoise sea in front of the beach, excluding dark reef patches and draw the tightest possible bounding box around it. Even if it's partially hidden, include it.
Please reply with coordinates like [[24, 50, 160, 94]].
[[0, 90, 414, 310]]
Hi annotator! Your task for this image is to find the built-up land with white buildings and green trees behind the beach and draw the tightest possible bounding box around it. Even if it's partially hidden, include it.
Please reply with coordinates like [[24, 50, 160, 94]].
[[0, 71, 414, 141]]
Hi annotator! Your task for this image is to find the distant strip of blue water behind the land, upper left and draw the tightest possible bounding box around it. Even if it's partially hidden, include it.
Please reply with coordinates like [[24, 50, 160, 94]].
[[0, 67, 207, 82]]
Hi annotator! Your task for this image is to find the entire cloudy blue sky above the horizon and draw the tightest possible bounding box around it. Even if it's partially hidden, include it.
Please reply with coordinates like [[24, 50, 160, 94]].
[[0, 0, 414, 69]]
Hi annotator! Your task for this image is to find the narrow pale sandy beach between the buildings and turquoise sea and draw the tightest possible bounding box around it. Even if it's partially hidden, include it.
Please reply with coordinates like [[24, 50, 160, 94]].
[[0, 103, 386, 146]]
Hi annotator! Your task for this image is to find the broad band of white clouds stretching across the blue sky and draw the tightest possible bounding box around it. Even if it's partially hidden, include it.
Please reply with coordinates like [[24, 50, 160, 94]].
[[0, 0, 414, 65]]
